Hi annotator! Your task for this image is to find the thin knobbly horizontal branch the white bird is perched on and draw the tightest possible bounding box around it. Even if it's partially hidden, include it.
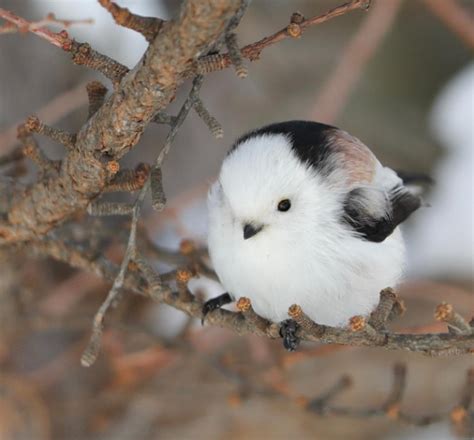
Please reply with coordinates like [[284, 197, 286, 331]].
[[32, 230, 474, 356]]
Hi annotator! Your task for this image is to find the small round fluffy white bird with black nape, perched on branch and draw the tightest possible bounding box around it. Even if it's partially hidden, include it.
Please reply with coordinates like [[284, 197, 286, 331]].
[[202, 120, 422, 351]]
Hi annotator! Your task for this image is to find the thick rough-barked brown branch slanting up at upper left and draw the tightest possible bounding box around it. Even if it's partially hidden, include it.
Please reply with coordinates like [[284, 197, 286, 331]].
[[0, 0, 240, 242]]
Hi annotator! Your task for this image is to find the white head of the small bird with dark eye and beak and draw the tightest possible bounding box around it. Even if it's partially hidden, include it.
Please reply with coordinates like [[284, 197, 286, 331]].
[[213, 133, 334, 244]]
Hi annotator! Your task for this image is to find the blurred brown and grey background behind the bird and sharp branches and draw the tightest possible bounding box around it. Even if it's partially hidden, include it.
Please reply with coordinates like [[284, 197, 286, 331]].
[[0, 0, 474, 440]]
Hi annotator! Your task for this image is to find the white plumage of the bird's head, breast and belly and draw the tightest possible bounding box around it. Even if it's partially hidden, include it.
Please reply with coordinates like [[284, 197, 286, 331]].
[[208, 135, 404, 326]]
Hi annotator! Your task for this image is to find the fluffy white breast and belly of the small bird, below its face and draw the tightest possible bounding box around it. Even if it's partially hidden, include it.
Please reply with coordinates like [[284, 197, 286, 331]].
[[208, 179, 404, 326]]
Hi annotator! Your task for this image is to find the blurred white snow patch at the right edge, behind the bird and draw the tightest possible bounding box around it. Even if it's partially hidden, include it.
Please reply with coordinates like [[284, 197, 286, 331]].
[[406, 64, 474, 280]]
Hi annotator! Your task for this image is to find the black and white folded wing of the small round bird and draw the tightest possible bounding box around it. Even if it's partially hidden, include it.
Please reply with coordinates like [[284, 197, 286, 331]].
[[343, 186, 421, 243]]
